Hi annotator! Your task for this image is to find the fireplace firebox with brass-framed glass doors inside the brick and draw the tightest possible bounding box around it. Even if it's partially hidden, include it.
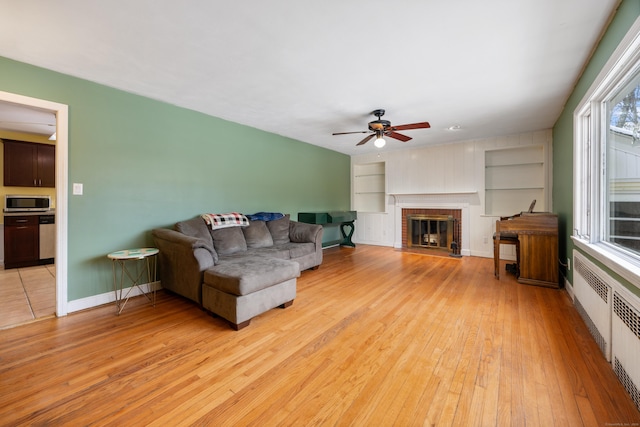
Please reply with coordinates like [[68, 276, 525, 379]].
[[407, 215, 454, 251]]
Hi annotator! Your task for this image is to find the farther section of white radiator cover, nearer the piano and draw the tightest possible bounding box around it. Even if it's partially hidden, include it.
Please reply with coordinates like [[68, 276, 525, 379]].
[[573, 251, 613, 362]]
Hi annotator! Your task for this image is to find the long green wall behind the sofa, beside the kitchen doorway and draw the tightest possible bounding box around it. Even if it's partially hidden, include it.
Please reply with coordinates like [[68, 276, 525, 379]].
[[0, 57, 350, 301]]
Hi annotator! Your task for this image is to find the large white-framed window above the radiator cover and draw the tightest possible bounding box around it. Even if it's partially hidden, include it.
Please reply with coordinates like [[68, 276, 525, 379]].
[[573, 19, 640, 287]]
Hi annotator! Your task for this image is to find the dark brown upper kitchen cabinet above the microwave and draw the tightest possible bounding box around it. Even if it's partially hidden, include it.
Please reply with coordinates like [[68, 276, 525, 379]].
[[3, 139, 56, 188]]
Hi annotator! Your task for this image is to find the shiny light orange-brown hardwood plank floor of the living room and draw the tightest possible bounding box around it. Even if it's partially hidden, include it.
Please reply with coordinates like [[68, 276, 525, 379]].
[[0, 245, 640, 426]]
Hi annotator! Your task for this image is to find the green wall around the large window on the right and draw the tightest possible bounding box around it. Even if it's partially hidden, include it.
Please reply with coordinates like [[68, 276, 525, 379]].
[[553, 0, 640, 288]]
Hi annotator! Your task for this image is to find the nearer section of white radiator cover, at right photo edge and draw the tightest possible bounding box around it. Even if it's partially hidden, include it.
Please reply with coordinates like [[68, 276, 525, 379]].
[[611, 289, 640, 409]]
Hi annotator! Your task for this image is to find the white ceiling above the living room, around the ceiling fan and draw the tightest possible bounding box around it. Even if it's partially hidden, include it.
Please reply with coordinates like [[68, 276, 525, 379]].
[[0, 0, 619, 154]]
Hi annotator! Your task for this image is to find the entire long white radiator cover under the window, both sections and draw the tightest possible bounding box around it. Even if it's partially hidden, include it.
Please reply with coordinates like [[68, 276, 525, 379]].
[[573, 251, 640, 409]]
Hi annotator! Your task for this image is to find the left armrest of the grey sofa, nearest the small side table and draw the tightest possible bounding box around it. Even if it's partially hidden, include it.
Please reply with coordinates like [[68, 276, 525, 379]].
[[151, 228, 218, 303]]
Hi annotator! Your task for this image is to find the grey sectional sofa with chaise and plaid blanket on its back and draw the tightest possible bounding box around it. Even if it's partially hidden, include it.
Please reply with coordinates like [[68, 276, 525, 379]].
[[152, 213, 322, 330]]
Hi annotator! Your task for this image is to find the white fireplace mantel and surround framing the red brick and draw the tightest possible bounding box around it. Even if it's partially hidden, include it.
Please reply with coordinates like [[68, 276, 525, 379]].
[[389, 191, 478, 256]]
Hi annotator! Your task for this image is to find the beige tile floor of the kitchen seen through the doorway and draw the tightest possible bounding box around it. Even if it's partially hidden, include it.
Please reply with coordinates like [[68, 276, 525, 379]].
[[0, 264, 56, 329]]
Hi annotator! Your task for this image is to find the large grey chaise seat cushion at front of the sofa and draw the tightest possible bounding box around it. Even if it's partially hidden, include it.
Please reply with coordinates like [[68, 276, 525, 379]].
[[204, 255, 300, 295]]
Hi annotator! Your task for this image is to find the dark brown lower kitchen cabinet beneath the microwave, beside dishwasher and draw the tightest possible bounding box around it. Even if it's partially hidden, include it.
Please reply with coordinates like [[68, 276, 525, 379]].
[[4, 215, 40, 268]]
